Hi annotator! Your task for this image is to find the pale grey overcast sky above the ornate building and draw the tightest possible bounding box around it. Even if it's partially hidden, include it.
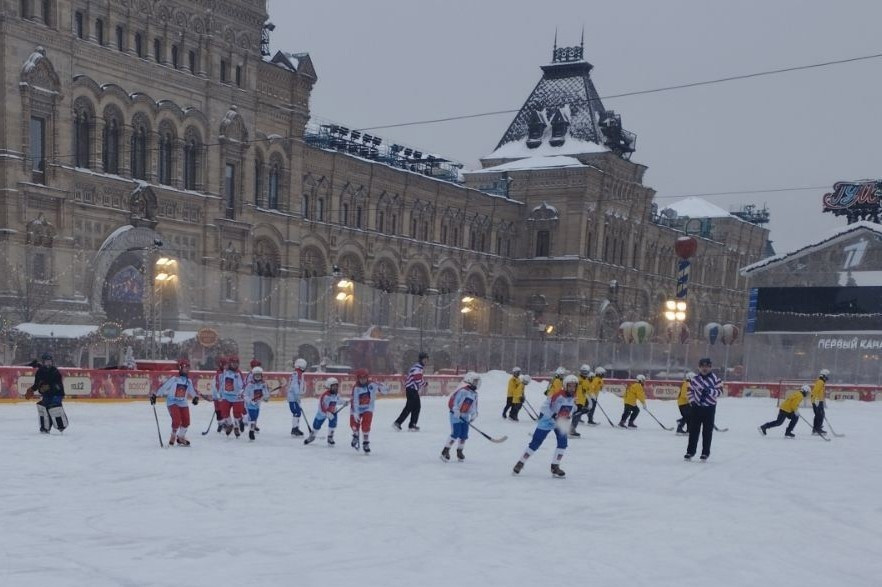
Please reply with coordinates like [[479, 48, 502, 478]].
[[269, 0, 882, 252]]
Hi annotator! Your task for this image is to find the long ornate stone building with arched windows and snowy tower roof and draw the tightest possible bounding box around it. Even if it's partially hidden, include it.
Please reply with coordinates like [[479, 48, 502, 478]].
[[0, 0, 767, 368]]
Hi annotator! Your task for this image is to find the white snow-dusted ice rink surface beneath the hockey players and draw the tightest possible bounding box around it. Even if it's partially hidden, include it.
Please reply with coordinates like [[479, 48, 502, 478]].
[[0, 374, 882, 587]]
